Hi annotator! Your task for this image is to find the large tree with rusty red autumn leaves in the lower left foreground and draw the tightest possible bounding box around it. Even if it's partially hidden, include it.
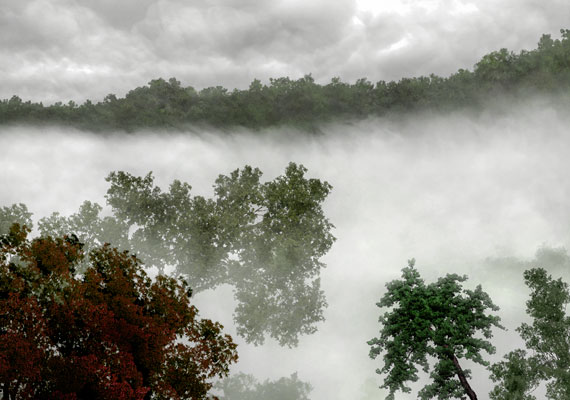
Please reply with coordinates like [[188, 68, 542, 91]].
[[0, 224, 237, 400]]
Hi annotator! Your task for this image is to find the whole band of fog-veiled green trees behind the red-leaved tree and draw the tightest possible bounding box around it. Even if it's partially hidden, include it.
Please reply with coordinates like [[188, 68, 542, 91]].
[[4, 163, 335, 346]]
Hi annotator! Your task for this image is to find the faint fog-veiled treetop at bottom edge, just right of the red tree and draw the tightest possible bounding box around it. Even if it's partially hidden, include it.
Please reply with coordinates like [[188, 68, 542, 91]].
[[217, 373, 312, 400]]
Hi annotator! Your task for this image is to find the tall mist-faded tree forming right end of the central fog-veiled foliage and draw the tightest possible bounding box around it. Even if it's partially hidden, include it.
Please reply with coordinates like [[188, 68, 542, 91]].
[[229, 164, 334, 345]]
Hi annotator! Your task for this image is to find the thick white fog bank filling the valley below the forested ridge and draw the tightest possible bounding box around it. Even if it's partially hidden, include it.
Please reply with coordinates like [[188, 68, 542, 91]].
[[0, 100, 570, 400]]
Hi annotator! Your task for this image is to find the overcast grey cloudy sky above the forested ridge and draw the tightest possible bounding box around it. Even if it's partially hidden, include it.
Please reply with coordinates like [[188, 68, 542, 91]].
[[0, 0, 570, 103]]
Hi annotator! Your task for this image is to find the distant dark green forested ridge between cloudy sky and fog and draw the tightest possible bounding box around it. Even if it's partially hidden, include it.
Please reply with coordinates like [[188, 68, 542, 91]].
[[0, 29, 570, 131]]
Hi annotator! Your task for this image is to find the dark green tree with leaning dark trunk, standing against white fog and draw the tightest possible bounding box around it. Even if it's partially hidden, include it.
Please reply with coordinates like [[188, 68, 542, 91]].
[[368, 260, 502, 399]]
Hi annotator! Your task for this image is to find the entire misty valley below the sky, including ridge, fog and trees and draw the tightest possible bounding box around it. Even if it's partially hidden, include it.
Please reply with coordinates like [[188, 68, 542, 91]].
[[0, 30, 570, 400]]
